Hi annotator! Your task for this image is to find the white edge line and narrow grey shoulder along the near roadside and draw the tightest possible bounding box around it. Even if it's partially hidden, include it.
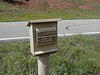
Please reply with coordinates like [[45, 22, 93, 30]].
[[0, 32, 100, 43]]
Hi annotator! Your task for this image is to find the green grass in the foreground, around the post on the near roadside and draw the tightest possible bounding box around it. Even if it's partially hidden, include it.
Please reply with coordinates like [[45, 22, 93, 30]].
[[0, 35, 100, 75]]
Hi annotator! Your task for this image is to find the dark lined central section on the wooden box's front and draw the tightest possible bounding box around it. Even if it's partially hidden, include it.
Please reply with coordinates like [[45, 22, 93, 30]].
[[37, 27, 57, 46]]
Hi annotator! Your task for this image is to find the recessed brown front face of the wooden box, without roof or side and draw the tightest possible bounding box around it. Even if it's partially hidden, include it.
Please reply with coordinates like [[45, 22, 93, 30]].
[[34, 23, 57, 54]]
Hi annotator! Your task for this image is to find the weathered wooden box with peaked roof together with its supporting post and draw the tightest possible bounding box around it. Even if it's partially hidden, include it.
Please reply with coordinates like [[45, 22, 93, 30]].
[[27, 18, 61, 75]]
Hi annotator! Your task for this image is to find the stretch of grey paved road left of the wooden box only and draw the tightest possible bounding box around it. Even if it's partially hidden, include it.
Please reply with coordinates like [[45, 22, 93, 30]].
[[0, 22, 29, 38]]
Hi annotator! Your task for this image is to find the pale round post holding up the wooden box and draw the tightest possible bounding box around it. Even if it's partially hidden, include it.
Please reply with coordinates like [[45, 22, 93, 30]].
[[38, 54, 49, 75]]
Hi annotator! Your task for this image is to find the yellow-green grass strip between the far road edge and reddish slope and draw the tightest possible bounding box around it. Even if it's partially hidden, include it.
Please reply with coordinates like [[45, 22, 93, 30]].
[[0, 2, 100, 22]]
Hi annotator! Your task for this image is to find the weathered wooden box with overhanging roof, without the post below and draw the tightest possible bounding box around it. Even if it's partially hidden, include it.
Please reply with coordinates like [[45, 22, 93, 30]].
[[27, 19, 60, 56]]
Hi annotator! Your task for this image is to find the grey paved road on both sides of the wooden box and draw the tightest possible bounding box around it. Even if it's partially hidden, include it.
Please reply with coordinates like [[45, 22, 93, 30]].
[[0, 19, 100, 39]]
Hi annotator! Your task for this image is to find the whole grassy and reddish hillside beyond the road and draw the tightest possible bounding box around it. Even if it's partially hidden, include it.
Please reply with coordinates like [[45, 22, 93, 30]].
[[0, 0, 100, 21]]
